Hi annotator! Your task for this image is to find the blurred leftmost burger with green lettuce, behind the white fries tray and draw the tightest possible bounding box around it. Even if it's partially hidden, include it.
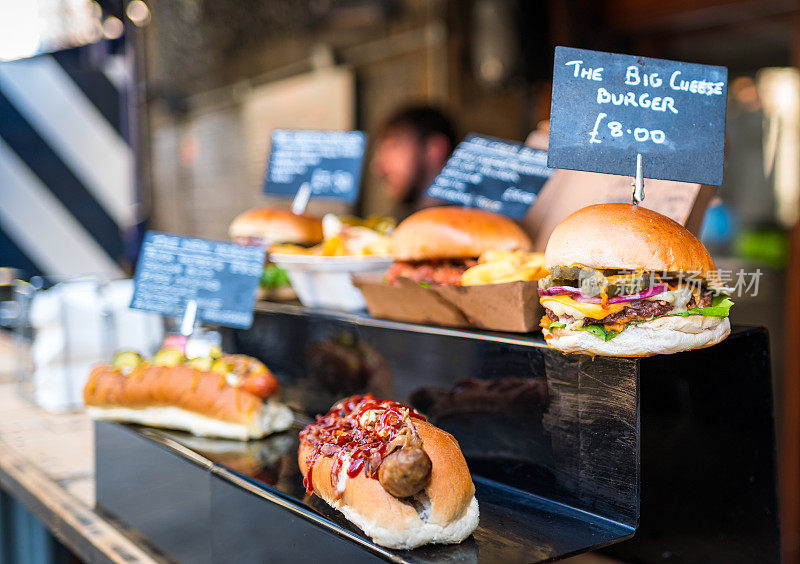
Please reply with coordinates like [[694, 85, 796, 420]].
[[228, 207, 322, 299]]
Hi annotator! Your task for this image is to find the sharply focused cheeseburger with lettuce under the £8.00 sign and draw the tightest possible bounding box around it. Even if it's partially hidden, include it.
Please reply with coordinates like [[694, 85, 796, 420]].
[[539, 204, 733, 357]]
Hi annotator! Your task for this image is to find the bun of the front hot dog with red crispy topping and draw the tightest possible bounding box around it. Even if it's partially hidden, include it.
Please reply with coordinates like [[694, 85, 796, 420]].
[[298, 420, 478, 549]]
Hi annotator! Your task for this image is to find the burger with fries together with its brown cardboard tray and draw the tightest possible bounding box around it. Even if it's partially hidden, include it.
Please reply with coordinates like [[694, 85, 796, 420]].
[[354, 206, 546, 333]]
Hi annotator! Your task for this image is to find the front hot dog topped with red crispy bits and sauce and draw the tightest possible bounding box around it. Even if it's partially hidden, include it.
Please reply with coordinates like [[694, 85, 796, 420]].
[[298, 394, 478, 549]]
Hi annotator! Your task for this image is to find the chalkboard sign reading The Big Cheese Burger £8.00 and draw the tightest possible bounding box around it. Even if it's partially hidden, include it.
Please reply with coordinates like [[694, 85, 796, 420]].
[[547, 47, 728, 186]]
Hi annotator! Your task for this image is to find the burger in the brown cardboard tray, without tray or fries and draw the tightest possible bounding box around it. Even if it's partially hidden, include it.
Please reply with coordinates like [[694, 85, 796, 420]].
[[386, 206, 531, 286]]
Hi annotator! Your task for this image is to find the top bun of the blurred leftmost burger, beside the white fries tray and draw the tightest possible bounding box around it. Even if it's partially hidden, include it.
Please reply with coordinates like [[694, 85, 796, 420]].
[[228, 208, 322, 245]]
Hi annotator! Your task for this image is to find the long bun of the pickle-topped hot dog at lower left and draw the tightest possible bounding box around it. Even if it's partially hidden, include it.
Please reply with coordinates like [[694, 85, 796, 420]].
[[83, 365, 294, 440]]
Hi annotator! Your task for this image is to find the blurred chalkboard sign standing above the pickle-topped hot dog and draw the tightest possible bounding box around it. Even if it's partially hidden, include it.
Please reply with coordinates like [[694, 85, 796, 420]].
[[131, 231, 265, 329]]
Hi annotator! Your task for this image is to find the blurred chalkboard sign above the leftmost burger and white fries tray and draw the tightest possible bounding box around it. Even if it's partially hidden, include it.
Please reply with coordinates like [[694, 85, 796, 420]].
[[264, 129, 367, 204]]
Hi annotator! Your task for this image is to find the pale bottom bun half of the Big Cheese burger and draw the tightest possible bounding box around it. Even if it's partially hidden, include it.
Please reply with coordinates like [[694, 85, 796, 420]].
[[542, 315, 731, 357]]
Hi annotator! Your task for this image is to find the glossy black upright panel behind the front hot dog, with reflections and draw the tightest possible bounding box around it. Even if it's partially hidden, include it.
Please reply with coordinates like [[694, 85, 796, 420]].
[[233, 306, 638, 525]]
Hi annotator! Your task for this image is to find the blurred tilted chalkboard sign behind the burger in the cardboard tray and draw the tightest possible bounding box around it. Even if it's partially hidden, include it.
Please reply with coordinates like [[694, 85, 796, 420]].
[[426, 134, 553, 219]]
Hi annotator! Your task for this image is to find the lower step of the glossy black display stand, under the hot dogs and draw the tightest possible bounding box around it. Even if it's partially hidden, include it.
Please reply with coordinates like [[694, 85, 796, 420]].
[[96, 422, 633, 564]]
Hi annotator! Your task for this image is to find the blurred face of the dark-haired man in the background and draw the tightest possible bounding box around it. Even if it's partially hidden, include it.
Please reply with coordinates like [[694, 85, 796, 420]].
[[372, 129, 423, 202]]
